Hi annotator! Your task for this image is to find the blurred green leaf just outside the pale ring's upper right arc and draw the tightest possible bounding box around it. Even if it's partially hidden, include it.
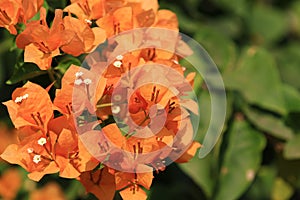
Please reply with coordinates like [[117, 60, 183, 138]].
[[195, 27, 236, 70]]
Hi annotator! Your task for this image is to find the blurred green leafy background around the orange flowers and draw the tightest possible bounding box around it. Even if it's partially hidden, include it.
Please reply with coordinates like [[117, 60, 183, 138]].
[[0, 0, 300, 200]]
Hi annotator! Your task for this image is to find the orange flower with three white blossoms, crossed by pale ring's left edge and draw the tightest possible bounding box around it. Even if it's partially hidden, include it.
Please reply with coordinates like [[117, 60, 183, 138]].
[[54, 65, 106, 117]]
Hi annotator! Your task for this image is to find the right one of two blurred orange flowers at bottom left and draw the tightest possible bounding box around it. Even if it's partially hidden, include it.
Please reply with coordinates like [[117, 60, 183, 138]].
[[29, 182, 66, 200]]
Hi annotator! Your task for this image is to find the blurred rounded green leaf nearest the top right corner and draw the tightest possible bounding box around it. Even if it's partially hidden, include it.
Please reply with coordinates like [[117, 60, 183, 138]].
[[247, 4, 288, 44]]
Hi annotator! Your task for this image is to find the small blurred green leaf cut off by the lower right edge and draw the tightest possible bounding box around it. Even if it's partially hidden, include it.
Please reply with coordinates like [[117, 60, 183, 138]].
[[283, 134, 300, 159]]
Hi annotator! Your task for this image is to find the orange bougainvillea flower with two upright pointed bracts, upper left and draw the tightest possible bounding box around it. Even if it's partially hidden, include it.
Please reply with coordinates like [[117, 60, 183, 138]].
[[16, 8, 63, 70]]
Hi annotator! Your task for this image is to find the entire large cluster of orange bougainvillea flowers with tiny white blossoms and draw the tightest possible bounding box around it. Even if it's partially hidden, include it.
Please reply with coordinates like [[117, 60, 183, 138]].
[[0, 0, 201, 200]]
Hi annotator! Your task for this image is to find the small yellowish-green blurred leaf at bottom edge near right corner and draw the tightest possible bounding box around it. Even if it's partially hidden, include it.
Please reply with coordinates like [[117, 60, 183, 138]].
[[272, 178, 293, 200]]
